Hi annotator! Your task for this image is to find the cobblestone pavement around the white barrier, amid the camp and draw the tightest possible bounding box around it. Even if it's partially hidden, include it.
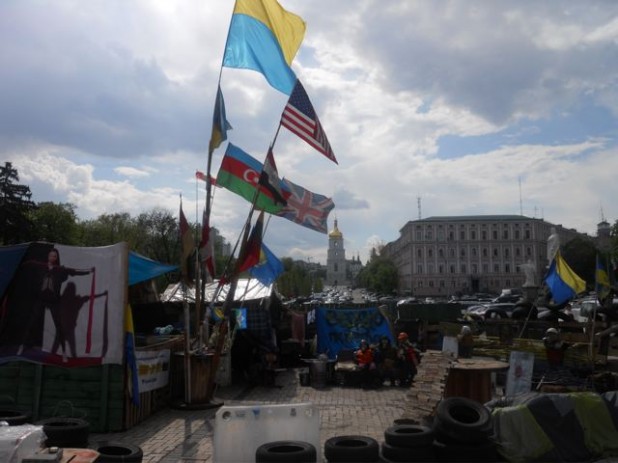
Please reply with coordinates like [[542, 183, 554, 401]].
[[90, 368, 410, 463]]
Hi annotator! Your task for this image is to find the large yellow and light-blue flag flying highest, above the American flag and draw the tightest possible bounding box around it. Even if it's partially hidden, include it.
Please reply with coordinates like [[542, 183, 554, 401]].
[[223, 0, 306, 95]]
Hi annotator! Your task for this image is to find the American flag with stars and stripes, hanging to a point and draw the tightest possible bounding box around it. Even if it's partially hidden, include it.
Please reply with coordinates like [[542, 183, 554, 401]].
[[281, 79, 338, 164]]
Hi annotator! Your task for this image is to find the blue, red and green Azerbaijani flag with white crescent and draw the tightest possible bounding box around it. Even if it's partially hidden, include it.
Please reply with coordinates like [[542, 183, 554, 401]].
[[217, 143, 290, 214]]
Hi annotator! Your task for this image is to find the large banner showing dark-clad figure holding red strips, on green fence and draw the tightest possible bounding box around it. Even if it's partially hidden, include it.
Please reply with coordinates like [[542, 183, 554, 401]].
[[0, 242, 128, 367]]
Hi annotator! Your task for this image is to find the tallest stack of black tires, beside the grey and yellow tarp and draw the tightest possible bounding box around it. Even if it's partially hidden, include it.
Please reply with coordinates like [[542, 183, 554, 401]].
[[433, 397, 503, 463]]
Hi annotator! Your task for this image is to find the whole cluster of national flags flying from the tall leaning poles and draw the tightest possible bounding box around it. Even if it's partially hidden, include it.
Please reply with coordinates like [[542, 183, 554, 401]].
[[196, 0, 337, 284]]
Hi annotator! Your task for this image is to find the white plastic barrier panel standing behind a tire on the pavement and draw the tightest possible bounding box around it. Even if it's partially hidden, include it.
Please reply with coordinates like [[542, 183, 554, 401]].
[[213, 403, 322, 463]]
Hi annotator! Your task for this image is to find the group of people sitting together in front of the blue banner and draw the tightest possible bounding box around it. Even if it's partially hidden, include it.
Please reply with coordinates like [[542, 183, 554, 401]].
[[356, 332, 421, 388]]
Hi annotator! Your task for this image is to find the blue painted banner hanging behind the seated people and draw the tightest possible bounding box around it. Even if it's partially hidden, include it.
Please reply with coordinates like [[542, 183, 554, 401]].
[[315, 307, 394, 359]]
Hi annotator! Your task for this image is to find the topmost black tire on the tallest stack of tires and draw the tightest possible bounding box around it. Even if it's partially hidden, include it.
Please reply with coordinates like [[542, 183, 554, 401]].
[[434, 397, 493, 442]]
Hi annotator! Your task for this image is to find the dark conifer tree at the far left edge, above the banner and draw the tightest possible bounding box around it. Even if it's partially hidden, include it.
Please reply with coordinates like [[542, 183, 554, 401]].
[[0, 162, 36, 245]]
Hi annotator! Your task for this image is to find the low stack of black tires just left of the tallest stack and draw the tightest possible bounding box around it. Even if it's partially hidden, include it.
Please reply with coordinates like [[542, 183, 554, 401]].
[[380, 424, 436, 463]]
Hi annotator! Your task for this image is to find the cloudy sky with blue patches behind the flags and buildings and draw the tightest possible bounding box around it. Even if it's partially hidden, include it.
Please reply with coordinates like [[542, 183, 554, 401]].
[[0, 0, 618, 263]]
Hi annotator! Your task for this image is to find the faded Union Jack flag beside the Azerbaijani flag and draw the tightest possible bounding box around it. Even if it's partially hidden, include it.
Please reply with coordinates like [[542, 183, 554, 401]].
[[276, 178, 335, 233]]
